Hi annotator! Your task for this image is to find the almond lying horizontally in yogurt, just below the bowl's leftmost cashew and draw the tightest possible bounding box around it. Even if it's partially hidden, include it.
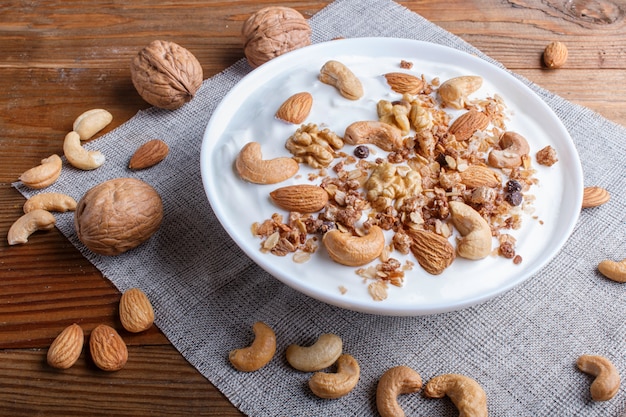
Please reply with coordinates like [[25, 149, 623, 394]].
[[270, 184, 328, 213]]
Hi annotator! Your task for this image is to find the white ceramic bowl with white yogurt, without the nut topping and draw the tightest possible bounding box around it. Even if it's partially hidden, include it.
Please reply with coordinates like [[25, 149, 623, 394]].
[[201, 38, 583, 315]]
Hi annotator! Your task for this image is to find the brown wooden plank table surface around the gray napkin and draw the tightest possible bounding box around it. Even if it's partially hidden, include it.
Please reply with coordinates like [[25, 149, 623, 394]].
[[0, 0, 626, 416]]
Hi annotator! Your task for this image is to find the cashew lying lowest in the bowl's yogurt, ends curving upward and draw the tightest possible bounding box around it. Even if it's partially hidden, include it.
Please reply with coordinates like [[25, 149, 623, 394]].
[[322, 226, 385, 266]]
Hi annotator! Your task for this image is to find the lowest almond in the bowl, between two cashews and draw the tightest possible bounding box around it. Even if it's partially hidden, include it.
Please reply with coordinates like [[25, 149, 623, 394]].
[[406, 229, 456, 275]]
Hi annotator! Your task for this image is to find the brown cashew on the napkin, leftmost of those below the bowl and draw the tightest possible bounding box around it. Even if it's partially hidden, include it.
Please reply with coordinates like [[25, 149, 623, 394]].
[[228, 321, 276, 372]]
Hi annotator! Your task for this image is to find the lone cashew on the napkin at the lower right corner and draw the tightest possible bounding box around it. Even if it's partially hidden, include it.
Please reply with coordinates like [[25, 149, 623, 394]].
[[576, 355, 621, 401]]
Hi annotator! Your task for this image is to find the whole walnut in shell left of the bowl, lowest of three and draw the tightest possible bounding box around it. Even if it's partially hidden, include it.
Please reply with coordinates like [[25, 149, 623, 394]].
[[74, 178, 163, 255]]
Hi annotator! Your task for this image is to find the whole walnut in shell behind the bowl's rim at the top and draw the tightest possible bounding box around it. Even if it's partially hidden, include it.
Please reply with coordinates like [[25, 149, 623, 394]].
[[241, 6, 311, 68]]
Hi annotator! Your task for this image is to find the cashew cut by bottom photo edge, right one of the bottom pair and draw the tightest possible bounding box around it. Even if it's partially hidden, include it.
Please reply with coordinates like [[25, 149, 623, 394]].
[[424, 374, 487, 417]]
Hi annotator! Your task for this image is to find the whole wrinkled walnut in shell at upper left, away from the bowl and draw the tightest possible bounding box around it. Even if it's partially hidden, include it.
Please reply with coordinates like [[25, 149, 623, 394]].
[[130, 40, 202, 110]]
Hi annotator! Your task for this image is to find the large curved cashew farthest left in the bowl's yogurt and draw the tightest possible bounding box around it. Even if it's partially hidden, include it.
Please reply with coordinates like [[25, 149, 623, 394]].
[[235, 142, 299, 184]]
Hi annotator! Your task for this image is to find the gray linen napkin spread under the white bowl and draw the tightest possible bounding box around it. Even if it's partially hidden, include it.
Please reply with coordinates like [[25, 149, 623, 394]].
[[15, 0, 626, 417]]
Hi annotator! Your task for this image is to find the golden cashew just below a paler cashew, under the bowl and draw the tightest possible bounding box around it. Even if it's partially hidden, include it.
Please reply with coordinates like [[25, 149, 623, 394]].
[[309, 354, 361, 399]]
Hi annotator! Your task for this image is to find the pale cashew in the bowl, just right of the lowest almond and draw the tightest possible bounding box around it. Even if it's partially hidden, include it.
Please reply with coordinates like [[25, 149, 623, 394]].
[[448, 201, 492, 259]]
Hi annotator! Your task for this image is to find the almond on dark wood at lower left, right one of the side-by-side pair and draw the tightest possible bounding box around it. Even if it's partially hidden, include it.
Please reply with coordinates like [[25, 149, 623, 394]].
[[89, 324, 128, 371]]
